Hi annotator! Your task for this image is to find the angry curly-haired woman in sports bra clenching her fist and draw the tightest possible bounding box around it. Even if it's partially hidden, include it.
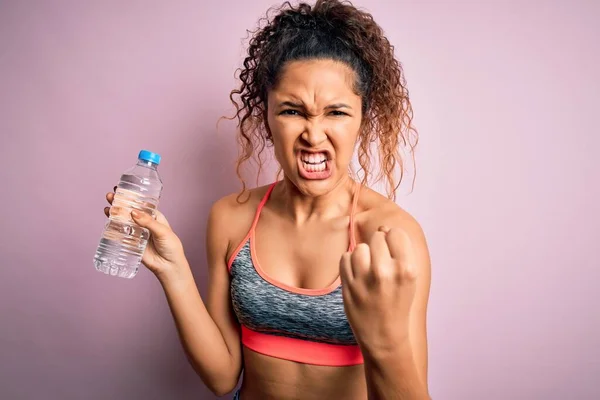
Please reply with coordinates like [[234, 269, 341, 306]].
[[105, 0, 430, 400]]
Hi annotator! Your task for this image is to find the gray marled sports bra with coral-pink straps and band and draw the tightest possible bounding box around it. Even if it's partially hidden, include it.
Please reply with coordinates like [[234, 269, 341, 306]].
[[227, 182, 363, 366]]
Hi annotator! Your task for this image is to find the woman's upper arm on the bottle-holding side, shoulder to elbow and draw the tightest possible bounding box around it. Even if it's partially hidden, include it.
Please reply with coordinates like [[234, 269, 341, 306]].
[[206, 197, 242, 377]]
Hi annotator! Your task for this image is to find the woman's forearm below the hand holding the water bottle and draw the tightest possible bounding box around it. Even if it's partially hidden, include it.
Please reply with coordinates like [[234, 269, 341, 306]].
[[159, 266, 240, 395]]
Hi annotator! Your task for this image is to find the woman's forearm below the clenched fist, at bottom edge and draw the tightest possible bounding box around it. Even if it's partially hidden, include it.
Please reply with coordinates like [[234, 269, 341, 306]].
[[363, 339, 430, 400]]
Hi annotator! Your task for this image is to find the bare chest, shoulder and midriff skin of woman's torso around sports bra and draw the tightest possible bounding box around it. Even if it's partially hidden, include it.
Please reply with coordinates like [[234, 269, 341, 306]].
[[227, 181, 408, 400]]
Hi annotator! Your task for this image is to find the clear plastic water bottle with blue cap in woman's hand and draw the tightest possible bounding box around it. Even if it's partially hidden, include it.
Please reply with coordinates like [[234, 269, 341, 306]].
[[94, 150, 163, 278]]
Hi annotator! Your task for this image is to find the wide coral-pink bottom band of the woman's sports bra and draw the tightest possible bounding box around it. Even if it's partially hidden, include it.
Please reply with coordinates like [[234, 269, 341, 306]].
[[242, 325, 364, 367]]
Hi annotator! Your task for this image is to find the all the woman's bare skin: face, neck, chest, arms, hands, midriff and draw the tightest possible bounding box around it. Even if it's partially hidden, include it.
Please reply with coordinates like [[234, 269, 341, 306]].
[[105, 60, 430, 400]]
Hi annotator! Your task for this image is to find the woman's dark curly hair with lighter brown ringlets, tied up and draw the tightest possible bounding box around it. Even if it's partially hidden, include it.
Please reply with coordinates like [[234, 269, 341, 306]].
[[229, 0, 418, 200]]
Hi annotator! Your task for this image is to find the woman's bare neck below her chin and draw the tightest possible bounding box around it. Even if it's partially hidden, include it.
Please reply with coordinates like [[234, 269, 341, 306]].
[[276, 175, 355, 224]]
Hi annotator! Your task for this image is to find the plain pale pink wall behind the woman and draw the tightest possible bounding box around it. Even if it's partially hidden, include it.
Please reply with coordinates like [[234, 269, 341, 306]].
[[0, 0, 600, 400]]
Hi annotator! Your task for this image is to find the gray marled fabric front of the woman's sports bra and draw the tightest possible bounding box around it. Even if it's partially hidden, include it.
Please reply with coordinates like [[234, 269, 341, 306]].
[[231, 239, 356, 345]]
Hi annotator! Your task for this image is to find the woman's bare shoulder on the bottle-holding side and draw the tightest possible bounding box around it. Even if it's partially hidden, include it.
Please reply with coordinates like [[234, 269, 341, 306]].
[[207, 185, 269, 266]]
